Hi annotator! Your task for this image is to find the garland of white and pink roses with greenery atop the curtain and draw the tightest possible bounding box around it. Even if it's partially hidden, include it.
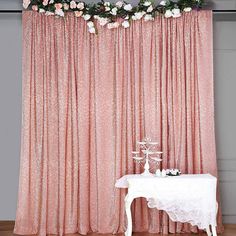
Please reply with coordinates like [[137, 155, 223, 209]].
[[23, 0, 204, 34]]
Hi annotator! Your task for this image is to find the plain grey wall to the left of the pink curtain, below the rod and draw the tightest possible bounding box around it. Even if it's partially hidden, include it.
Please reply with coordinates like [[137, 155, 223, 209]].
[[0, 14, 21, 220]]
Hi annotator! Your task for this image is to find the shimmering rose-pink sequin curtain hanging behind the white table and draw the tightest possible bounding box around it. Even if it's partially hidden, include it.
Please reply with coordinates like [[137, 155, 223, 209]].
[[15, 11, 221, 236]]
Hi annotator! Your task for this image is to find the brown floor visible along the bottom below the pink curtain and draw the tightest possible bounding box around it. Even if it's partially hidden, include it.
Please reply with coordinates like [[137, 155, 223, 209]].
[[0, 221, 236, 236]]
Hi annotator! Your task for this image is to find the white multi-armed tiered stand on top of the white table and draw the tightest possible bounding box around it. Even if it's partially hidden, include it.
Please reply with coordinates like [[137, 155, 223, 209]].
[[132, 138, 163, 176]]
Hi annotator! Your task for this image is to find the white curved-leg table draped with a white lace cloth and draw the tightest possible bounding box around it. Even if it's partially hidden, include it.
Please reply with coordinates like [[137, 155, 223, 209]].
[[115, 174, 218, 236]]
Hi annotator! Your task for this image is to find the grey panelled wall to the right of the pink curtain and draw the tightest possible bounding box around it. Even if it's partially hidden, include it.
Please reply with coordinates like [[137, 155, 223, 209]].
[[214, 16, 236, 223]]
